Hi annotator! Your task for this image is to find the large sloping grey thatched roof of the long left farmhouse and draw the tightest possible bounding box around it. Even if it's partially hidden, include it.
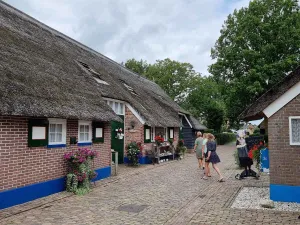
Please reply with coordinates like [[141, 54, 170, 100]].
[[0, 1, 187, 127]]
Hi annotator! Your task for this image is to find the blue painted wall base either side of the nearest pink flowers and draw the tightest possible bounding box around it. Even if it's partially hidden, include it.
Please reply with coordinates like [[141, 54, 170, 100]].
[[0, 166, 111, 210]]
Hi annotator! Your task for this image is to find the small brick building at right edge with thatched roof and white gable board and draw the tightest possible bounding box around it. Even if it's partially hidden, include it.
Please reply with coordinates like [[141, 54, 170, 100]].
[[241, 67, 300, 203]]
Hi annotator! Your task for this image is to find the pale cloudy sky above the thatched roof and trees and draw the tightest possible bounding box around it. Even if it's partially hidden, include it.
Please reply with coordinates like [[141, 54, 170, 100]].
[[5, 0, 249, 75]]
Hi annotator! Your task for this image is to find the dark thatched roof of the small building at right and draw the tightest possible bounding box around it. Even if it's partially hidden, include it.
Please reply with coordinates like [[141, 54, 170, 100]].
[[240, 67, 300, 121]]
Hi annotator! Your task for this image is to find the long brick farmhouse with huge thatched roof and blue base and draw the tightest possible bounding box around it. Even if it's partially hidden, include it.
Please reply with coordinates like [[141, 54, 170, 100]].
[[0, 1, 195, 209]]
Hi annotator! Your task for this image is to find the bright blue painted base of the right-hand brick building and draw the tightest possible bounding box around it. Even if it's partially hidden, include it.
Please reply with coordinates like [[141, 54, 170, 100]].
[[270, 184, 300, 203]]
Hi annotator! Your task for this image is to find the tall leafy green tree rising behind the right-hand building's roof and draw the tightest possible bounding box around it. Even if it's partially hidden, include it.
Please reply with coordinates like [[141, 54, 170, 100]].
[[209, 0, 300, 125]]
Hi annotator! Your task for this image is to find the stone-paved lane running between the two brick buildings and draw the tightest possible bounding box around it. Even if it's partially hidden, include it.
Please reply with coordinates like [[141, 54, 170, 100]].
[[0, 145, 300, 225]]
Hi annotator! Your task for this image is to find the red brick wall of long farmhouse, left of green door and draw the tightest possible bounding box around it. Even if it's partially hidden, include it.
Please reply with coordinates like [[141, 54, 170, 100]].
[[0, 116, 111, 191]]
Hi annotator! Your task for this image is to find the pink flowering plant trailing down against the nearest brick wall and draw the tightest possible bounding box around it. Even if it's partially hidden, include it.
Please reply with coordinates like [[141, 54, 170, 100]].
[[64, 148, 97, 194]]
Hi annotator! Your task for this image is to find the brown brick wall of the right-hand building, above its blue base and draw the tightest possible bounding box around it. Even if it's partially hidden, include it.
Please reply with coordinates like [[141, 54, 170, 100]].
[[268, 95, 300, 186]]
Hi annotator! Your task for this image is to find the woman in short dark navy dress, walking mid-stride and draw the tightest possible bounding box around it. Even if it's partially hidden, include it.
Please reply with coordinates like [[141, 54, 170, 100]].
[[203, 134, 224, 182]]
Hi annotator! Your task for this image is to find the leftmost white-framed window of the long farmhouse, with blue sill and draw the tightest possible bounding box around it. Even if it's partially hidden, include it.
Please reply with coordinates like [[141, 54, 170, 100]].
[[48, 119, 67, 146]]
